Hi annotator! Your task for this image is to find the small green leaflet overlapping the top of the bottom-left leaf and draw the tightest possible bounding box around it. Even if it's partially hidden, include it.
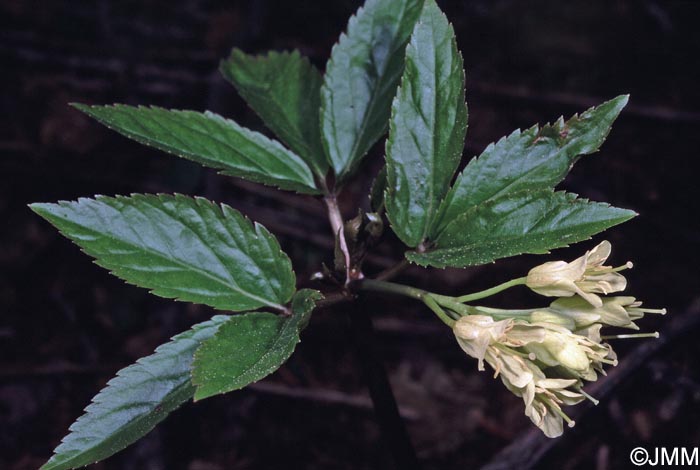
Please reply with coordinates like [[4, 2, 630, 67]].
[[192, 289, 322, 401]]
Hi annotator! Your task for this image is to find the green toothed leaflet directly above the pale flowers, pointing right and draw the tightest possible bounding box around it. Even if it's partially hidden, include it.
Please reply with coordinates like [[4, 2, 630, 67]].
[[406, 190, 636, 268]]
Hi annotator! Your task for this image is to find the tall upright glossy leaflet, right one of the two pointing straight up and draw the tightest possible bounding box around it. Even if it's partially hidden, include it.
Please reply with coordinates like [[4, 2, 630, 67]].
[[386, 0, 467, 247]]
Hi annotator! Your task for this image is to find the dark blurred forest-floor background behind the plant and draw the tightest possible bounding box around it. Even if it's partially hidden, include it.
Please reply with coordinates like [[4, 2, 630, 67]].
[[0, 0, 700, 470]]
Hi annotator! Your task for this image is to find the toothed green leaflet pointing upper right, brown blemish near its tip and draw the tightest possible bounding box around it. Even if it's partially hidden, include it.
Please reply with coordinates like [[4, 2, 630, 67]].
[[439, 95, 629, 229]]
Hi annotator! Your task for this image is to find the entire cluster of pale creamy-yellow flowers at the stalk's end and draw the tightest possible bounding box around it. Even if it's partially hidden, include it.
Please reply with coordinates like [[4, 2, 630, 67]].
[[453, 242, 666, 437]]
